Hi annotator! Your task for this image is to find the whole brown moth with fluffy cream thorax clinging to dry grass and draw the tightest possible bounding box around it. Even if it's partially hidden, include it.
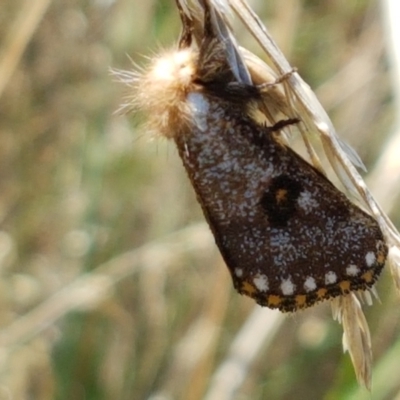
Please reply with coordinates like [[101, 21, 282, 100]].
[[126, 0, 388, 312]]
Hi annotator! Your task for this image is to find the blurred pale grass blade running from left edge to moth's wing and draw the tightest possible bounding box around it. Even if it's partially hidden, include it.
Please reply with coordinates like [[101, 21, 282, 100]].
[[0, 224, 214, 348]]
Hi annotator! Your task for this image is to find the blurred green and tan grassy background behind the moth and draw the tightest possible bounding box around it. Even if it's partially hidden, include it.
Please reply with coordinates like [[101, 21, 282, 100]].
[[0, 0, 400, 400]]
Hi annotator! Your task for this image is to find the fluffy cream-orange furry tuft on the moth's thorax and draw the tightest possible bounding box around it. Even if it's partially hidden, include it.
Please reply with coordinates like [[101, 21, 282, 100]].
[[138, 49, 197, 138]]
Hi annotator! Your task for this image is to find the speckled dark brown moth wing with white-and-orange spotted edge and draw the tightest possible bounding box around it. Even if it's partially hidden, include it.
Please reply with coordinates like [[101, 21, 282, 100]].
[[175, 91, 387, 311]]
